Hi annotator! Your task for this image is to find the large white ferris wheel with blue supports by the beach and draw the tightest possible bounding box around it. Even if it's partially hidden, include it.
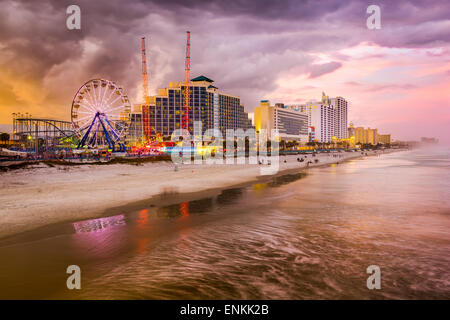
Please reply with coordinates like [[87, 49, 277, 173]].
[[72, 79, 131, 151]]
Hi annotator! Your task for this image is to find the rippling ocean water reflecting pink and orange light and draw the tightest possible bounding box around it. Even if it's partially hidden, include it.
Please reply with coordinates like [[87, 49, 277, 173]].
[[0, 148, 450, 299]]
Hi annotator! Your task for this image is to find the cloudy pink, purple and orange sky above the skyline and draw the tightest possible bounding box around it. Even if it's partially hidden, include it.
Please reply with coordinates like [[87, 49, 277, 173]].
[[0, 0, 450, 144]]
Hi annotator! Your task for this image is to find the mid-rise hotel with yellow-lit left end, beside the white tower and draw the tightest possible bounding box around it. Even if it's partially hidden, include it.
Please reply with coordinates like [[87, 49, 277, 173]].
[[254, 100, 308, 143]]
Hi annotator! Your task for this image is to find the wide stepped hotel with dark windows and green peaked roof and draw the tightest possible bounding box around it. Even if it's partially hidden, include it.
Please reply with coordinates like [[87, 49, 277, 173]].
[[142, 76, 252, 136]]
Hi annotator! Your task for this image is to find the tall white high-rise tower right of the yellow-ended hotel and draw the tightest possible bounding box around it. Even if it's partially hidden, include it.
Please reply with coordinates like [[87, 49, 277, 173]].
[[298, 92, 348, 142]]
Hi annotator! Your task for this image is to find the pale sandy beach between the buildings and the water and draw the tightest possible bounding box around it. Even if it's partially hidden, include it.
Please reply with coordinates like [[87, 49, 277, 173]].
[[0, 149, 406, 240]]
